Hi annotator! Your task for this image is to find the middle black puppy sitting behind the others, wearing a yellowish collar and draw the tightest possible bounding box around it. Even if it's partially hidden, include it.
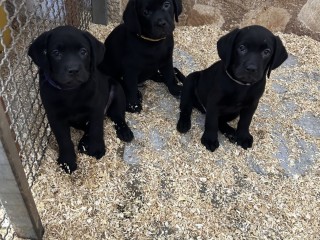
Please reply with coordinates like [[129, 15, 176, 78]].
[[99, 0, 182, 112]]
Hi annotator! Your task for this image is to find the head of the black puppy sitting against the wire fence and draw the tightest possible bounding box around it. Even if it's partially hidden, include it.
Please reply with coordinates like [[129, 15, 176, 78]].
[[28, 26, 104, 89]]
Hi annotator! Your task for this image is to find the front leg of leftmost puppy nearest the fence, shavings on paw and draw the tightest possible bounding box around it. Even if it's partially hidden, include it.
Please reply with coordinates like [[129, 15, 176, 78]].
[[48, 119, 77, 174]]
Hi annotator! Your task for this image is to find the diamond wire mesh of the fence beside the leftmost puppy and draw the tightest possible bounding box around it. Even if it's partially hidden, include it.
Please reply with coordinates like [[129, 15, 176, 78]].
[[0, 0, 91, 240]]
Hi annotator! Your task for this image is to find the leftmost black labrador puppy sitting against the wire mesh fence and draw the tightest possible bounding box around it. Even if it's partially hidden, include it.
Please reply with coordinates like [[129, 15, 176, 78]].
[[28, 26, 133, 173]]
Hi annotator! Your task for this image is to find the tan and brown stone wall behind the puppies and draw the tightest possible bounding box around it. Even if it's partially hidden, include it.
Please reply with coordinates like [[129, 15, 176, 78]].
[[107, 0, 320, 41]]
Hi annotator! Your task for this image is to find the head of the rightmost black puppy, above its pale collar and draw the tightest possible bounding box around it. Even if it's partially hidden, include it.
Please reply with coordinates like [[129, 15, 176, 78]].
[[217, 26, 288, 84]]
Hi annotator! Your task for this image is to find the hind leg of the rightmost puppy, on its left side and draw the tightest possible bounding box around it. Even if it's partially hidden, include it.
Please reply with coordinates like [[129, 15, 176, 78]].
[[177, 74, 196, 133]]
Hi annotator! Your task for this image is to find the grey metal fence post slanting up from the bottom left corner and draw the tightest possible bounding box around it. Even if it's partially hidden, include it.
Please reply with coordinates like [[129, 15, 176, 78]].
[[0, 97, 44, 239]]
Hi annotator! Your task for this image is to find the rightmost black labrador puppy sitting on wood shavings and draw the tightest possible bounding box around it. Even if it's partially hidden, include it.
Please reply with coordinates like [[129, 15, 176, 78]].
[[177, 26, 288, 151]]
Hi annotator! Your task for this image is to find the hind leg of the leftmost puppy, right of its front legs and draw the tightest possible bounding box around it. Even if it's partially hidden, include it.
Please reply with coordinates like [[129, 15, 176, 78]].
[[107, 83, 133, 142]]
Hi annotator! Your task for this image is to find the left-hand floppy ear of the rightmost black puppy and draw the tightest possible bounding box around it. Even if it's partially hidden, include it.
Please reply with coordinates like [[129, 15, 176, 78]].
[[217, 28, 240, 69]]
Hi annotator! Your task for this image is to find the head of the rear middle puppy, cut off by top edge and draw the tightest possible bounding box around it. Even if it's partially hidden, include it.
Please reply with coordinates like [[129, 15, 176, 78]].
[[123, 0, 182, 39]]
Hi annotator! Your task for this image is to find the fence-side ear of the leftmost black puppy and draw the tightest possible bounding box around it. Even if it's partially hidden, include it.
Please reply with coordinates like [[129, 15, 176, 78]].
[[28, 32, 50, 69]]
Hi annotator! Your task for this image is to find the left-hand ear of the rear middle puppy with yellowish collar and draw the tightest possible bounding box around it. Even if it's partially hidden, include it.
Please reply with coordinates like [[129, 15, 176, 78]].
[[123, 0, 141, 35]]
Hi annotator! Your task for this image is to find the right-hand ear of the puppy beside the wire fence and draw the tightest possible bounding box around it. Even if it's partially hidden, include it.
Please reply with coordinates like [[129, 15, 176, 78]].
[[84, 31, 105, 68]]
